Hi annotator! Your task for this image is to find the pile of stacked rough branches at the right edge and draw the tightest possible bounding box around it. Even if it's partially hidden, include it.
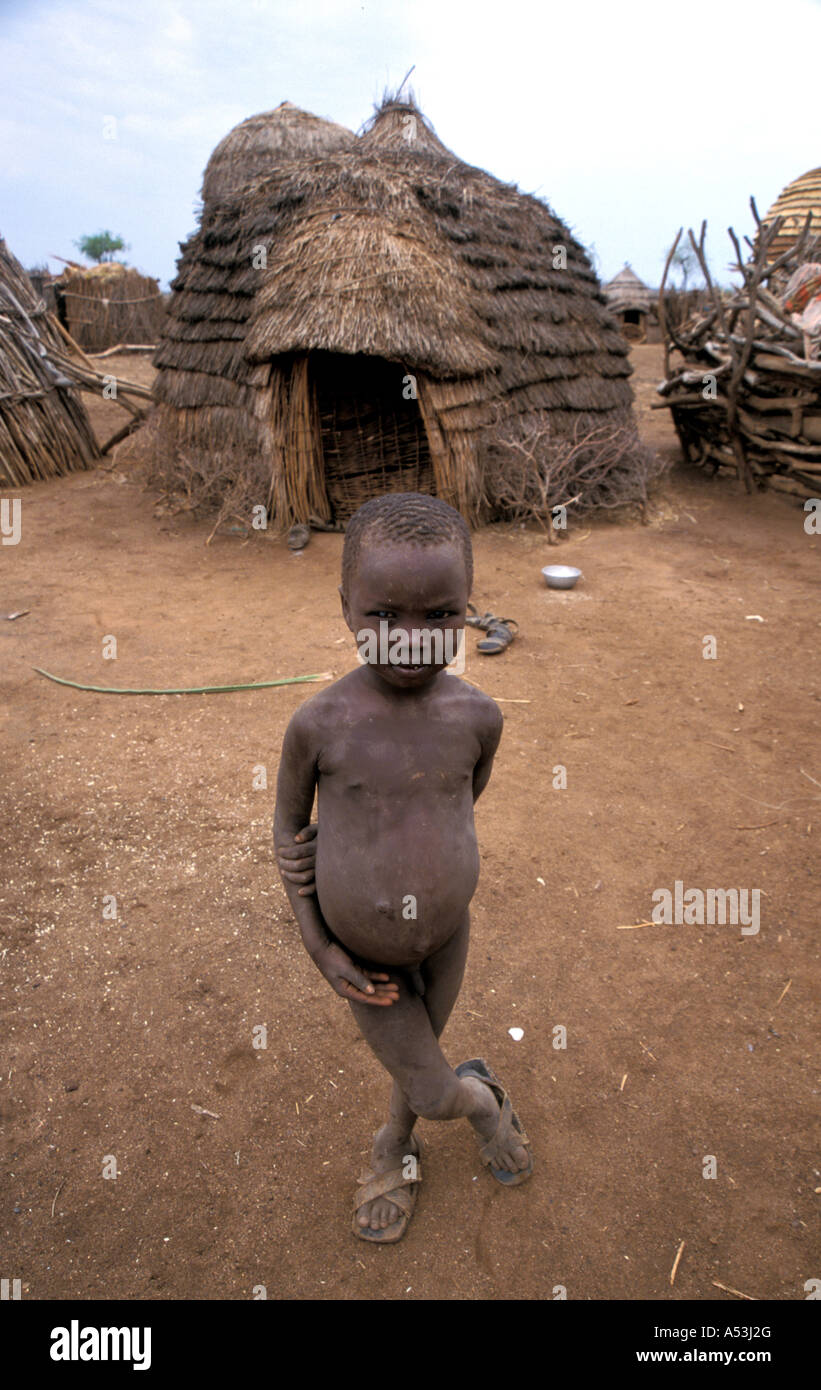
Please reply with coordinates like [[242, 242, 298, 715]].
[[653, 199, 821, 495]]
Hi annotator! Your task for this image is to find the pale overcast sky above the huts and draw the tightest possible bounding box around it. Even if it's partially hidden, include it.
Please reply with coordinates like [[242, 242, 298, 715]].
[[0, 0, 821, 285]]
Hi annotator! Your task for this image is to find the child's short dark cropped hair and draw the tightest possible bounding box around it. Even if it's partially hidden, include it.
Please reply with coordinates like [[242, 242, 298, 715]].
[[342, 492, 474, 594]]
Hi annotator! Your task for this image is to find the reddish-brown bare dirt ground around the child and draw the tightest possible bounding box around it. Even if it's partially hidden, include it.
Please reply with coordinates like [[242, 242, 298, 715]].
[[0, 348, 821, 1307]]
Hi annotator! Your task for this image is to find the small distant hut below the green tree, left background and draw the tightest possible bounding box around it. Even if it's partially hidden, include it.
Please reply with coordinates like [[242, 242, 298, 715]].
[[53, 261, 165, 352]]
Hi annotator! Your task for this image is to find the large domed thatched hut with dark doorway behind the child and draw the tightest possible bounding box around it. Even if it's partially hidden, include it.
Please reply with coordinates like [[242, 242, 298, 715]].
[[154, 99, 655, 525]]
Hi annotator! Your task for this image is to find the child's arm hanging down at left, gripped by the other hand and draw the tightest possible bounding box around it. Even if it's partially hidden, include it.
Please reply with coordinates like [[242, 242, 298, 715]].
[[274, 710, 399, 1005]]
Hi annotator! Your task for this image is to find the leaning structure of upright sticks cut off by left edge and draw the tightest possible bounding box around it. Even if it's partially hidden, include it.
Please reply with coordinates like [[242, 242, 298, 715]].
[[0, 238, 100, 488]]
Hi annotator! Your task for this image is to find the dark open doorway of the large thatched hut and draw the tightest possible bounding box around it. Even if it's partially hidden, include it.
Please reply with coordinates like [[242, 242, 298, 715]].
[[308, 353, 435, 523]]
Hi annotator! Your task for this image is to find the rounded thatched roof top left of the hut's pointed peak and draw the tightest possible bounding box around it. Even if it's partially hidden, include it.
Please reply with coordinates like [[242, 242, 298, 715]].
[[203, 101, 356, 204]]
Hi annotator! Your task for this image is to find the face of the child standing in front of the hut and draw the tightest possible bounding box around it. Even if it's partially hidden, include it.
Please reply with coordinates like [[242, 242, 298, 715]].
[[339, 542, 470, 689]]
